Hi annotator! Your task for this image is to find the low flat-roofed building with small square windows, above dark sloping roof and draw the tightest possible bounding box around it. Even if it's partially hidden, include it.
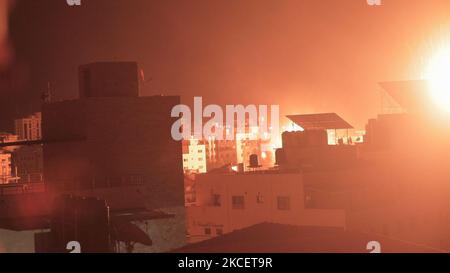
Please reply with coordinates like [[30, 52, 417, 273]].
[[187, 171, 345, 242]]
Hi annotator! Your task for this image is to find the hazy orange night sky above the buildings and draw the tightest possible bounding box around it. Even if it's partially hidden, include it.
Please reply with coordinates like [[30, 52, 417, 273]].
[[0, 0, 450, 130]]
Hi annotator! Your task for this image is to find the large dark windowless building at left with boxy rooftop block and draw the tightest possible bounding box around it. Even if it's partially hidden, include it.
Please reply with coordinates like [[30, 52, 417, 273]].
[[42, 62, 185, 251]]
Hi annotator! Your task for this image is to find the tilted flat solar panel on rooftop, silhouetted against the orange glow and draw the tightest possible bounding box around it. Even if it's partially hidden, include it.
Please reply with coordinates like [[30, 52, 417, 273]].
[[287, 113, 353, 130]]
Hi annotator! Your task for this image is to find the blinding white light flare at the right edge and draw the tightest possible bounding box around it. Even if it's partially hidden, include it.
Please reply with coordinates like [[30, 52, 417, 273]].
[[424, 47, 450, 112]]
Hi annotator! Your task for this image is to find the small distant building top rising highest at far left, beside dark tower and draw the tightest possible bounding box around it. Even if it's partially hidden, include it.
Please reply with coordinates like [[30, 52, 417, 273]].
[[14, 112, 42, 140]]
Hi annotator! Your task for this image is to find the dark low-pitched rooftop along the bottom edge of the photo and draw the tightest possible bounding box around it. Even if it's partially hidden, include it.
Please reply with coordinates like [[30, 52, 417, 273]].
[[172, 223, 443, 253]]
